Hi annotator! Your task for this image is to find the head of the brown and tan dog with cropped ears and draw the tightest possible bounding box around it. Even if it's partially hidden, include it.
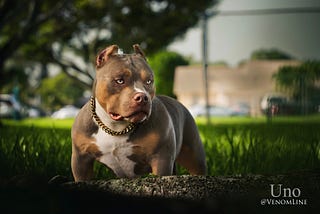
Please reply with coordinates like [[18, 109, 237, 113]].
[[93, 45, 155, 123]]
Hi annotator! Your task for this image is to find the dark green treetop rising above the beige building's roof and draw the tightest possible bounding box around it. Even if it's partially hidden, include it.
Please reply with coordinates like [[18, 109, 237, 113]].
[[250, 48, 292, 60]]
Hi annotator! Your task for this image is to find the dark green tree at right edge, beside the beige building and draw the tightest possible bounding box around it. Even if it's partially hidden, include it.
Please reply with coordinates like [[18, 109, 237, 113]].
[[273, 61, 320, 114]]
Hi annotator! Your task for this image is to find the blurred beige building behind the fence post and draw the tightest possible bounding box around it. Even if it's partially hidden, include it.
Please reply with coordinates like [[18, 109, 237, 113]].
[[174, 60, 300, 116]]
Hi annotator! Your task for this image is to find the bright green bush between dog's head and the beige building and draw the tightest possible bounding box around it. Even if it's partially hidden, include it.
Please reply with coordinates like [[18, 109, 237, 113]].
[[149, 51, 188, 97]]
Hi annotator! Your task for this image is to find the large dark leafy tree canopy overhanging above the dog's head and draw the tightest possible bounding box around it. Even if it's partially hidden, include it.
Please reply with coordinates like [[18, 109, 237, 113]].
[[0, 0, 216, 86]]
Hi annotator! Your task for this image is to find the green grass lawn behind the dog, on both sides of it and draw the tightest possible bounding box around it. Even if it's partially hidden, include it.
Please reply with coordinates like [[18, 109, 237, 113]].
[[0, 115, 320, 178]]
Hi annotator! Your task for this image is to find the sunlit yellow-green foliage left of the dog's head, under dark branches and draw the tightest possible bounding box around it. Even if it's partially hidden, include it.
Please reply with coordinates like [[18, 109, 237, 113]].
[[39, 73, 84, 110]]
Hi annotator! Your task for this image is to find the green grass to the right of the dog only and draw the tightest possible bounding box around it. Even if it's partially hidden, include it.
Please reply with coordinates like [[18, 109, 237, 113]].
[[199, 123, 320, 175]]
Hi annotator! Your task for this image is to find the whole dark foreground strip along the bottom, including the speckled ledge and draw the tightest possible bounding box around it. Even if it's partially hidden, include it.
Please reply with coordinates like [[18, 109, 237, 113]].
[[0, 170, 320, 214]]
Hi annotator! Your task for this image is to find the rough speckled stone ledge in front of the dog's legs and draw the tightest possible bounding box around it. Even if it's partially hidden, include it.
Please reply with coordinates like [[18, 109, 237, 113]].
[[63, 171, 320, 201]]
